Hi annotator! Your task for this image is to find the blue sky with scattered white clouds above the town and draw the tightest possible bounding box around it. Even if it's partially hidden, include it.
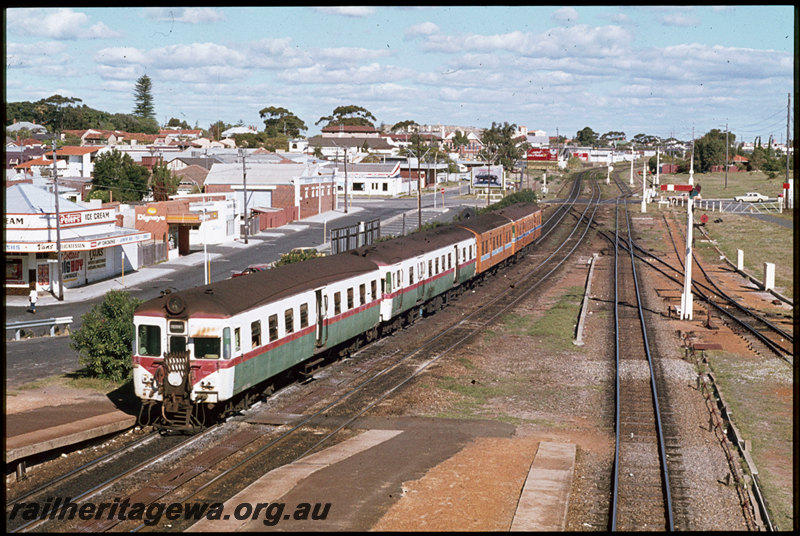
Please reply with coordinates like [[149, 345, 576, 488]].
[[5, 5, 796, 142]]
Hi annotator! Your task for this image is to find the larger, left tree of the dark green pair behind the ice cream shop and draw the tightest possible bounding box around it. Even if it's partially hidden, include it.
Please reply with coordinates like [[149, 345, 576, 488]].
[[92, 149, 150, 202]]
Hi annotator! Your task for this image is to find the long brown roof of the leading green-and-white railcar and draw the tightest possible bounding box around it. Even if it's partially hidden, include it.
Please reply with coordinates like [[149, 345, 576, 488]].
[[135, 253, 377, 317]]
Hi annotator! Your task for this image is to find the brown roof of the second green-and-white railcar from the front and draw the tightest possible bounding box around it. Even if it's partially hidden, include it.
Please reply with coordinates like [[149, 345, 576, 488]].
[[351, 225, 472, 264]]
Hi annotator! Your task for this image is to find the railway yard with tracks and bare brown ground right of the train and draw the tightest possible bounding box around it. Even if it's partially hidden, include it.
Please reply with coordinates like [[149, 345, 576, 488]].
[[6, 172, 795, 532]]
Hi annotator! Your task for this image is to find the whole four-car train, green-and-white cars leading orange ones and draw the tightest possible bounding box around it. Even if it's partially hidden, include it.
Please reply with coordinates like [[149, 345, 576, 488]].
[[132, 203, 542, 431]]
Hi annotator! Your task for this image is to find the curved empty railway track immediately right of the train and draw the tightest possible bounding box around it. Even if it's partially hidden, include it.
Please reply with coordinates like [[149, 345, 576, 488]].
[[12, 175, 599, 532]]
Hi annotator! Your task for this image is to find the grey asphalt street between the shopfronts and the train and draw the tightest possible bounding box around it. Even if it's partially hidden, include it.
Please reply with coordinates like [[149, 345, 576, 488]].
[[6, 191, 480, 388]]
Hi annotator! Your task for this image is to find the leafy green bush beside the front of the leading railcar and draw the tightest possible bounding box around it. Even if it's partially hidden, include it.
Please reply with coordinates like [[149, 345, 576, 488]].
[[70, 290, 142, 382]]
